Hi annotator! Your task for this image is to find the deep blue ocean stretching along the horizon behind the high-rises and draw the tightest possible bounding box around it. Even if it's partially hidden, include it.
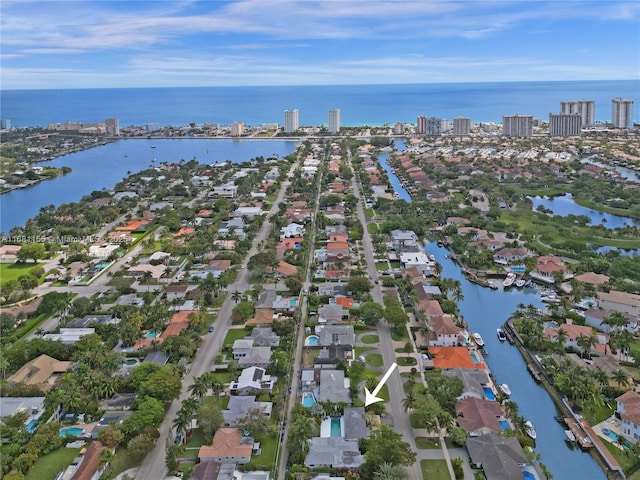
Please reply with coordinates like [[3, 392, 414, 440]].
[[0, 80, 640, 127]]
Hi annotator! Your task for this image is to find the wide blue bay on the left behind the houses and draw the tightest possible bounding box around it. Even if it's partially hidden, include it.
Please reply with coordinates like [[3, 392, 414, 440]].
[[0, 139, 298, 234]]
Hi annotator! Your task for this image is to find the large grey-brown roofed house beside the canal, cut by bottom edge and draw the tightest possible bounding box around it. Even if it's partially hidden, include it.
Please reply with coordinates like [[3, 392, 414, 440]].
[[466, 433, 544, 480]]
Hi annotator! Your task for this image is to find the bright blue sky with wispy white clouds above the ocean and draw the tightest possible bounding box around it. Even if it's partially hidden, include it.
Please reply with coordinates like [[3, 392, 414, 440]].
[[0, 0, 640, 89]]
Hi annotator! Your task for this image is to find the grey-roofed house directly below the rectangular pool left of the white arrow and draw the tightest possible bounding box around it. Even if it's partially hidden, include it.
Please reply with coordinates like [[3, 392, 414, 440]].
[[304, 437, 364, 469]]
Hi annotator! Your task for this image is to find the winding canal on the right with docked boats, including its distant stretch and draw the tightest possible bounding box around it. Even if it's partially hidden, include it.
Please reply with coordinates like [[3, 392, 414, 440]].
[[378, 142, 606, 480]]
